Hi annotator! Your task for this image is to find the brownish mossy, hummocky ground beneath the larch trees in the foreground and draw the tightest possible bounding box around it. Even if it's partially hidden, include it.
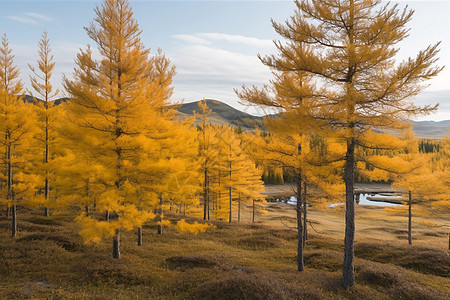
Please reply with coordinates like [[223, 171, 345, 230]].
[[0, 203, 450, 299]]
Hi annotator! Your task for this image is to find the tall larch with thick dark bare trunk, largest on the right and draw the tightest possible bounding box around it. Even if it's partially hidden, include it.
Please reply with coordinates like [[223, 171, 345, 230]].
[[237, 0, 442, 288]]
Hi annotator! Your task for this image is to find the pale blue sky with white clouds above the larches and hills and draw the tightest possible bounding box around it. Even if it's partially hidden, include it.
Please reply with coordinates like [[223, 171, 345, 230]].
[[0, 0, 450, 121]]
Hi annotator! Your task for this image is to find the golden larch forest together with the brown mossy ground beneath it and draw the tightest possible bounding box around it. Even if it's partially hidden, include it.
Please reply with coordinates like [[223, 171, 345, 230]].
[[0, 0, 450, 299]]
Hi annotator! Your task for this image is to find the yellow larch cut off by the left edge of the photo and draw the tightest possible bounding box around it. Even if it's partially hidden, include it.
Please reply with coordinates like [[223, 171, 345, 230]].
[[0, 35, 36, 238]]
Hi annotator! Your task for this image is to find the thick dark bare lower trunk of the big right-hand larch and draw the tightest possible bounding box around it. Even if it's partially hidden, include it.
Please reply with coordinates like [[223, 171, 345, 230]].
[[342, 138, 355, 289]]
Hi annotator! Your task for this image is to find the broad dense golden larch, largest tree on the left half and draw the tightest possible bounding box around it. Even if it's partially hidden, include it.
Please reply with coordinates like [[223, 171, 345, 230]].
[[64, 0, 181, 258]]
